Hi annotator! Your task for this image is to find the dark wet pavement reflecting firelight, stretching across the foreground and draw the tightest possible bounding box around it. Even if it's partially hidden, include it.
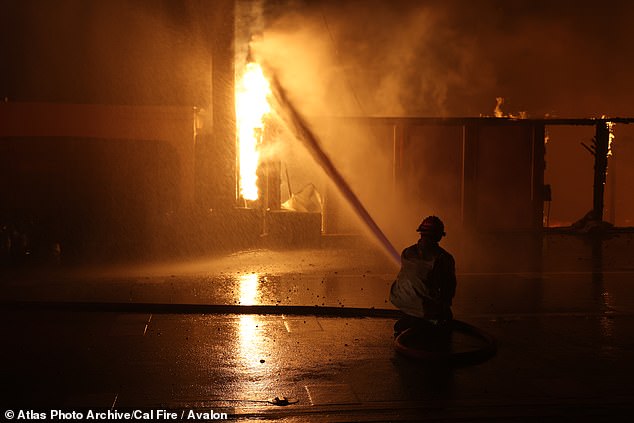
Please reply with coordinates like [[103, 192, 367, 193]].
[[0, 243, 634, 421]]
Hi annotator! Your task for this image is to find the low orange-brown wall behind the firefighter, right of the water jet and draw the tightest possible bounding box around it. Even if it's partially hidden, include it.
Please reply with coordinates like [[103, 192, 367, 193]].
[[324, 118, 544, 267]]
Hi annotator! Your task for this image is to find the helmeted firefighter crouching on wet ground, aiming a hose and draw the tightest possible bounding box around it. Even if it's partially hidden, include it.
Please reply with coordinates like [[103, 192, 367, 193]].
[[390, 216, 456, 336]]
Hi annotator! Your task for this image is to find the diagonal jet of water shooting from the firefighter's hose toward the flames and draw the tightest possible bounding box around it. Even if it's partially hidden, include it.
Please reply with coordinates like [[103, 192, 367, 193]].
[[268, 71, 401, 265]]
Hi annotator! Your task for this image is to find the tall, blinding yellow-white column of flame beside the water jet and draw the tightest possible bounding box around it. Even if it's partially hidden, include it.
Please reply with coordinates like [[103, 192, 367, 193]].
[[236, 63, 271, 201]]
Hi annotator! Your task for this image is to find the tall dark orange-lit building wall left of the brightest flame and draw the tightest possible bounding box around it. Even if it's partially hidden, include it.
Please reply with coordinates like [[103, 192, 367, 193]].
[[0, 0, 236, 260]]
